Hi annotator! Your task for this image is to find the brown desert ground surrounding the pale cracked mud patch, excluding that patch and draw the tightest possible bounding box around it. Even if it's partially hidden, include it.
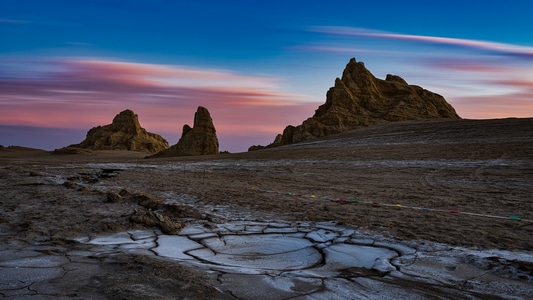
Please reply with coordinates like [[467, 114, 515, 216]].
[[0, 119, 533, 299]]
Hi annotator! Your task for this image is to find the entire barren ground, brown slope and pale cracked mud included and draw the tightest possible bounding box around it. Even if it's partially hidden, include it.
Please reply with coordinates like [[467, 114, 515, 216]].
[[0, 119, 533, 299]]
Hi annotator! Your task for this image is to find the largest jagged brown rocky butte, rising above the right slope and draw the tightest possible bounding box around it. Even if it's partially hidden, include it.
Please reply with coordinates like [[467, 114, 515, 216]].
[[249, 58, 460, 150]]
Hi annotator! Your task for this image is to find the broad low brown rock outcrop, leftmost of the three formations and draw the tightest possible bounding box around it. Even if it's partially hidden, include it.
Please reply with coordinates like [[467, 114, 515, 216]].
[[69, 109, 168, 153]]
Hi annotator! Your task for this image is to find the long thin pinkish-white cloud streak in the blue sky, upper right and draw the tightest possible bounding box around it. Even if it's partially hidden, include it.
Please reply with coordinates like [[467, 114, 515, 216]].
[[311, 26, 533, 59]]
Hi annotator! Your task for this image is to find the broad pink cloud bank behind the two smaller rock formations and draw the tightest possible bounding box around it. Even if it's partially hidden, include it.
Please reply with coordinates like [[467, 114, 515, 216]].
[[0, 59, 317, 150]]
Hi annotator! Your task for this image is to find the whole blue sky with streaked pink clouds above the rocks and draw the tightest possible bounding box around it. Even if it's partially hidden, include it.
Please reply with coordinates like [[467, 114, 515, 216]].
[[0, 0, 533, 152]]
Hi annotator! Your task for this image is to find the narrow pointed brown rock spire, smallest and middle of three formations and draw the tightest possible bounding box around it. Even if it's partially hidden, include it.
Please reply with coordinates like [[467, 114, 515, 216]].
[[155, 106, 218, 157]]
